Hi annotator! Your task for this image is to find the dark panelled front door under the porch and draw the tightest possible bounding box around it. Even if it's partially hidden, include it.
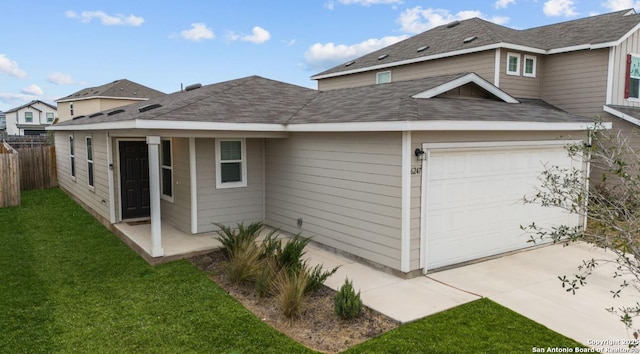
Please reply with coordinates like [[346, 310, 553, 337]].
[[119, 141, 151, 219]]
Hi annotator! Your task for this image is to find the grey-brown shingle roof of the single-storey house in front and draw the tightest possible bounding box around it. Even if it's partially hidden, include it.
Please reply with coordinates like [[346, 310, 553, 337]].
[[58, 73, 591, 126]]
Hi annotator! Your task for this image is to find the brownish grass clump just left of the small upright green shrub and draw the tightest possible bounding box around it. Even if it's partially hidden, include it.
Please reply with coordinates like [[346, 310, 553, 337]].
[[274, 267, 309, 320]]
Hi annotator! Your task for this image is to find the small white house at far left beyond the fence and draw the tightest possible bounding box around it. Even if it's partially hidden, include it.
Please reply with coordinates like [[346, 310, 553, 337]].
[[5, 100, 57, 135]]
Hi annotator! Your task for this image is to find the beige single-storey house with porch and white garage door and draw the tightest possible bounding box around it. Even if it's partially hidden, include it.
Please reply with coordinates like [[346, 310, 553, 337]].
[[49, 72, 611, 276]]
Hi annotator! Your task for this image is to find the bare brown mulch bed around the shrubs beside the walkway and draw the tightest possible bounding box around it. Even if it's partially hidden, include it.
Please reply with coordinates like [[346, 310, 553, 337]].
[[189, 250, 398, 353]]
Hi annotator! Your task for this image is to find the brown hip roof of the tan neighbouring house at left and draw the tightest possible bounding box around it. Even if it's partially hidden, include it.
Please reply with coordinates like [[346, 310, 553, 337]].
[[57, 79, 165, 101]]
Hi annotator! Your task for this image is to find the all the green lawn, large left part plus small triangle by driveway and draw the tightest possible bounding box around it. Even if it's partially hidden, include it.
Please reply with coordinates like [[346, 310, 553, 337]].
[[0, 189, 579, 353]]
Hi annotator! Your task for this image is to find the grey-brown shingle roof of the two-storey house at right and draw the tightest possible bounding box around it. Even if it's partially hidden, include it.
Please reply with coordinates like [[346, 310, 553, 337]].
[[312, 9, 640, 78]]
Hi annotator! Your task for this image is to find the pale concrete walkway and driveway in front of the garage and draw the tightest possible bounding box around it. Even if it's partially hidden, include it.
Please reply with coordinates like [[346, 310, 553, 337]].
[[307, 244, 638, 348]]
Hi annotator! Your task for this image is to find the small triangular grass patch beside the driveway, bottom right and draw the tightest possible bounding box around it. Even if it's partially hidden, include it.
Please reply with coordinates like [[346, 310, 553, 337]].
[[347, 298, 583, 354]]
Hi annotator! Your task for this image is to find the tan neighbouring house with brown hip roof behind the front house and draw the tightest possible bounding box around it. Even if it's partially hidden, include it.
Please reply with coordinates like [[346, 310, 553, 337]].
[[56, 79, 164, 121]]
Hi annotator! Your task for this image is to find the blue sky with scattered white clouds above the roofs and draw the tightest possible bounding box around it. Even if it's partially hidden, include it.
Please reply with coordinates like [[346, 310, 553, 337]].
[[0, 0, 640, 111]]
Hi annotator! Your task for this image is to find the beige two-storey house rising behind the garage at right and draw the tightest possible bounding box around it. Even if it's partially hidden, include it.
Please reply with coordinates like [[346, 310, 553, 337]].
[[312, 9, 640, 147]]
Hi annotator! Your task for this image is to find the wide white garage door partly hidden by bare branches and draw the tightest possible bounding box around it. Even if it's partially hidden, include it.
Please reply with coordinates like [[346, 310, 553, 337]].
[[423, 141, 582, 269]]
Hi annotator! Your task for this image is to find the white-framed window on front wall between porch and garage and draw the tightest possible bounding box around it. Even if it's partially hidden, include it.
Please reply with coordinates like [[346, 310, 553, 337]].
[[216, 139, 247, 188]]
